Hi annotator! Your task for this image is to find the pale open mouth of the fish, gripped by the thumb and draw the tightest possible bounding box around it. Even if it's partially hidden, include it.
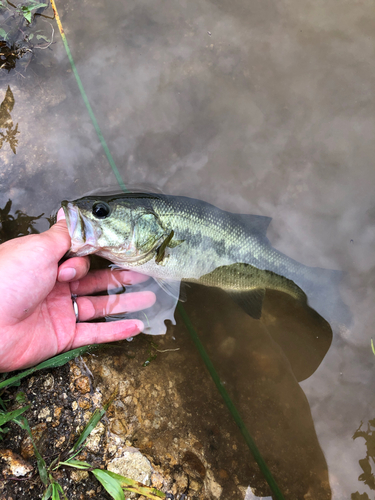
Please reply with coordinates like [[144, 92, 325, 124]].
[[61, 200, 99, 257]]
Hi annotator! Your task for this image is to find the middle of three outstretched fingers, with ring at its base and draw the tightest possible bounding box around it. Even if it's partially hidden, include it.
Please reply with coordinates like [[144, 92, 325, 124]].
[[77, 291, 156, 321]]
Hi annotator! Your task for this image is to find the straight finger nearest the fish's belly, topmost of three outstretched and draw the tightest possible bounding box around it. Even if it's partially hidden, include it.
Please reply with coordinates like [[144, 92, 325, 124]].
[[70, 269, 149, 295]]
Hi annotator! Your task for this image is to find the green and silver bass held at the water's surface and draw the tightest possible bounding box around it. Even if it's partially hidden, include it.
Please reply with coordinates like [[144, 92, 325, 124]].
[[61, 192, 347, 328]]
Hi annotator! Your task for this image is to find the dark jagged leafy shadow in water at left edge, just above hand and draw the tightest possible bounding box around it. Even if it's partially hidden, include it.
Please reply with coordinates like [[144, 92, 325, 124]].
[[0, 200, 44, 243]]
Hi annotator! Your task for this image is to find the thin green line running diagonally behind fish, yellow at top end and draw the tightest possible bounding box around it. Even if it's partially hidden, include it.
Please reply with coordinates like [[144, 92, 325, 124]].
[[51, 0, 284, 500]]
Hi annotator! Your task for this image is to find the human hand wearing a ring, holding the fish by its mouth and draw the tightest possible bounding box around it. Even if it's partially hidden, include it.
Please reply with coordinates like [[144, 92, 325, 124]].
[[0, 213, 155, 372]]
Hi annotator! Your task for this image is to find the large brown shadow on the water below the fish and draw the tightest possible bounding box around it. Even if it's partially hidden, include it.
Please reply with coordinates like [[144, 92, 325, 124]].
[[184, 285, 332, 500]]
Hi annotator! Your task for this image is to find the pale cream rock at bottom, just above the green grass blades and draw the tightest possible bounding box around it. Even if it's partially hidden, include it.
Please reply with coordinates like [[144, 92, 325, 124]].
[[107, 448, 152, 485]]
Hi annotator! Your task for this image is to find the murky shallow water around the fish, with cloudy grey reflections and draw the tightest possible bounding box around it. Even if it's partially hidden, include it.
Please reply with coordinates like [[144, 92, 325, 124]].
[[0, 0, 375, 499]]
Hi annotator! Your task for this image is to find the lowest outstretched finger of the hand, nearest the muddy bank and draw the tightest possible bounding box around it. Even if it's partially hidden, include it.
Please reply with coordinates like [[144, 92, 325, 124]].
[[70, 319, 144, 349]]
